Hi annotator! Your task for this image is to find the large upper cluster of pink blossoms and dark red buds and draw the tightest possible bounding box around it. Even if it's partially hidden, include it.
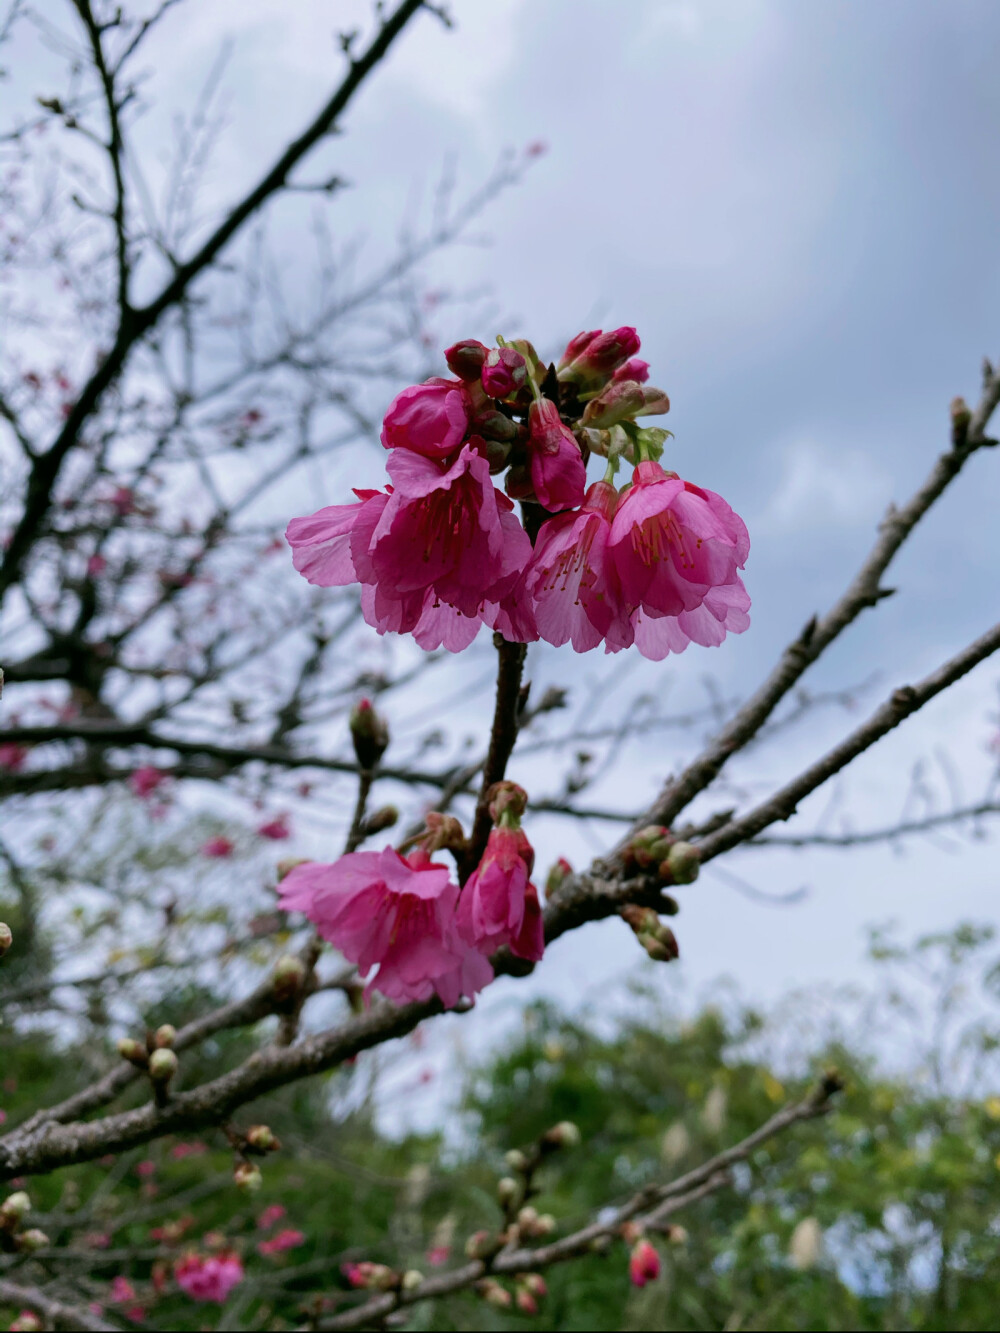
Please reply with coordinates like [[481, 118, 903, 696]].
[[287, 328, 749, 661]]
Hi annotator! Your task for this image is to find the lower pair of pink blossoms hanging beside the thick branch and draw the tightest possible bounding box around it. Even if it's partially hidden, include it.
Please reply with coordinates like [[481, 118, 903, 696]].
[[279, 782, 545, 1008]]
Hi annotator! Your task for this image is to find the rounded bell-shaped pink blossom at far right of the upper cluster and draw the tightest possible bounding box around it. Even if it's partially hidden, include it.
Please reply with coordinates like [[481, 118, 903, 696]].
[[607, 463, 749, 652]]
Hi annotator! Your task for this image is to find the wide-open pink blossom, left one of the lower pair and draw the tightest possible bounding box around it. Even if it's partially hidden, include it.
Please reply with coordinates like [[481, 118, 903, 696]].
[[277, 848, 493, 1008]]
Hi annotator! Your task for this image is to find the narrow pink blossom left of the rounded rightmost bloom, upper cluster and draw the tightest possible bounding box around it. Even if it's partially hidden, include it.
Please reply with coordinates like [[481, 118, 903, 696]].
[[525, 481, 624, 653]]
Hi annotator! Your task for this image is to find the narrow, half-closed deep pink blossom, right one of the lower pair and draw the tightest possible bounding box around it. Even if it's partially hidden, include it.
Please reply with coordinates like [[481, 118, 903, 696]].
[[456, 824, 544, 960]]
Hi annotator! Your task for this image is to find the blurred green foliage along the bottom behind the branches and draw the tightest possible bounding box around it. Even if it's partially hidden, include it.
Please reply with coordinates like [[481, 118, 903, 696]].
[[0, 925, 1000, 1330]]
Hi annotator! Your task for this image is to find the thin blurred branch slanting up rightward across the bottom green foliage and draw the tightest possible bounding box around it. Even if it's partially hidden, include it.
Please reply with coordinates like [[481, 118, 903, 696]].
[[319, 1073, 843, 1330]]
